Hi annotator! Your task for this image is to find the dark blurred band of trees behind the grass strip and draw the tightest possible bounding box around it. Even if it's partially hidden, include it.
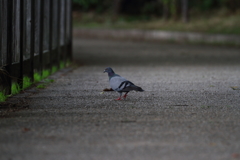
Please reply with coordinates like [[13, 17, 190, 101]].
[[73, 0, 240, 22]]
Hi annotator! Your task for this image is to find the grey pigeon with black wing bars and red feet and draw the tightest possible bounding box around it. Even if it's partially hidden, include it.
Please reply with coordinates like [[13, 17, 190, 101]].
[[103, 67, 144, 100]]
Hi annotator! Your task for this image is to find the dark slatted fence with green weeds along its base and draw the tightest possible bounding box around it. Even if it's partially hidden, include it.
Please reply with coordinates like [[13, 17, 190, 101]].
[[0, 0, 72, 94]]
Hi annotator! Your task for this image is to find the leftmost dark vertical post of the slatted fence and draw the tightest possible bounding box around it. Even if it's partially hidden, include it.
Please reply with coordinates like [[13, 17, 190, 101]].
[[6, 0, 13, 94]]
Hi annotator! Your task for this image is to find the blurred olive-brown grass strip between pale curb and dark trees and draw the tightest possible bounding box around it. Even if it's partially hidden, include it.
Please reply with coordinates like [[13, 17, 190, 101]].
[[74, 10, 240, 35]]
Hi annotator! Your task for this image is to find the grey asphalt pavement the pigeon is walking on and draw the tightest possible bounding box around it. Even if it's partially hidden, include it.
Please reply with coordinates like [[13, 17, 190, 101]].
[[0, 39, 240, 160]]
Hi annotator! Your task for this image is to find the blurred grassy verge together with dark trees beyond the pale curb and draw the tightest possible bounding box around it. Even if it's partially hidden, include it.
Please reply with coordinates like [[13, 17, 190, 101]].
[[73, 0, 240, 35]]
